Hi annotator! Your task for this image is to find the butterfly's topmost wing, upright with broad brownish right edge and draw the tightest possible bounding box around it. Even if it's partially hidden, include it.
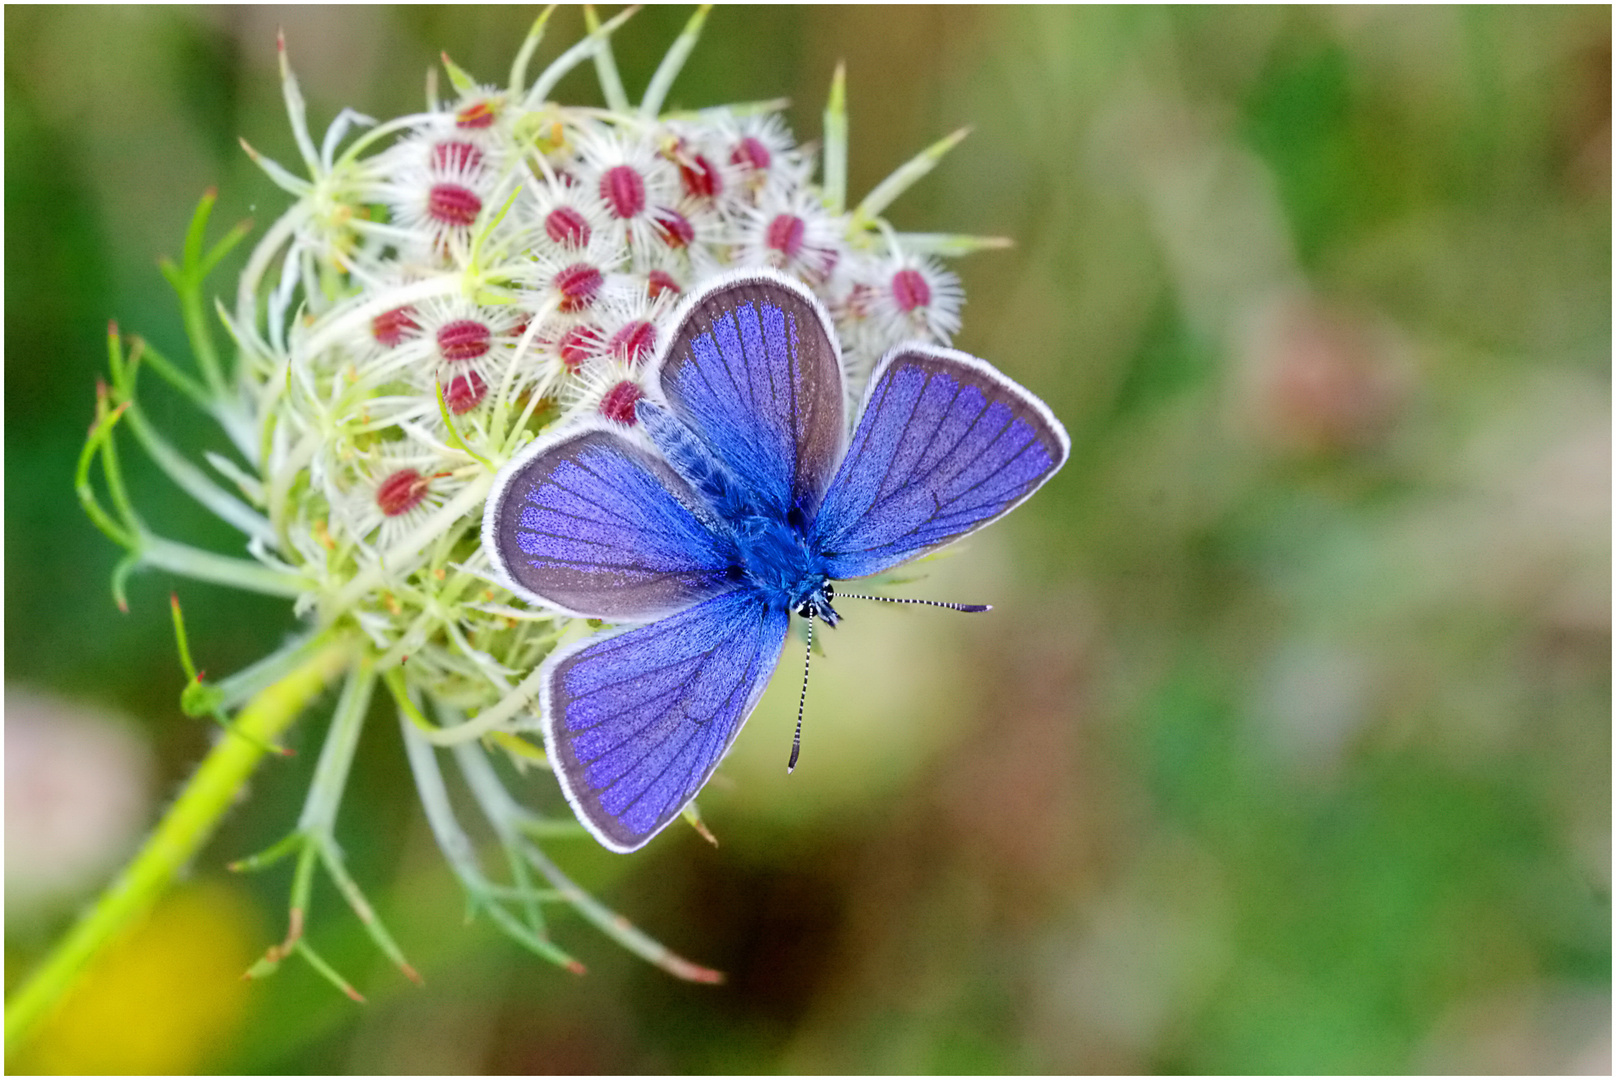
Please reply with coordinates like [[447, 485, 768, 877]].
[[653, 270, 845, 519]]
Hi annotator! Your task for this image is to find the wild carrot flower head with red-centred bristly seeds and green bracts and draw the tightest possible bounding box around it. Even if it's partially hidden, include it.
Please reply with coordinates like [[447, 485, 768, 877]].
[[28, 6, 1000, 1030]]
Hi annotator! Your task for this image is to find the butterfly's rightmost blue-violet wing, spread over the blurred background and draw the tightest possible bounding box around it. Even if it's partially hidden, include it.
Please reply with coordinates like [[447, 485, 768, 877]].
[[811, 344, 1071, 579]]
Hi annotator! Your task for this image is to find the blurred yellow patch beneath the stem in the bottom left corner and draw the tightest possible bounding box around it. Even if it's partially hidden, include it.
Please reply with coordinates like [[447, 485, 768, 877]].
[[16, 881, 257, 1075]]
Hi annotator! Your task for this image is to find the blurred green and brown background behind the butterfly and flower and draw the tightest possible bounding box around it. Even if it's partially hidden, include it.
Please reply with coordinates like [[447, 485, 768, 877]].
[[5, 6, 1611, 1072]]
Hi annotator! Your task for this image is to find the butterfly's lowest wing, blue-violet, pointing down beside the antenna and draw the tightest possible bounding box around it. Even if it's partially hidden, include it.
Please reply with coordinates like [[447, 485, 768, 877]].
[[541, 590, 790, 852]]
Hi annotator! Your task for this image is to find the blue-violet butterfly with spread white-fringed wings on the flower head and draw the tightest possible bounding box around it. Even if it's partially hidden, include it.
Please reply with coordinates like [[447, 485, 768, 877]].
[[483, 272, 1070, 852]]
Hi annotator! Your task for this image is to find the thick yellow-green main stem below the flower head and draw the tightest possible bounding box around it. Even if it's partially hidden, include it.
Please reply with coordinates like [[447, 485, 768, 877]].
[[5, 637, 352, 1056]]
